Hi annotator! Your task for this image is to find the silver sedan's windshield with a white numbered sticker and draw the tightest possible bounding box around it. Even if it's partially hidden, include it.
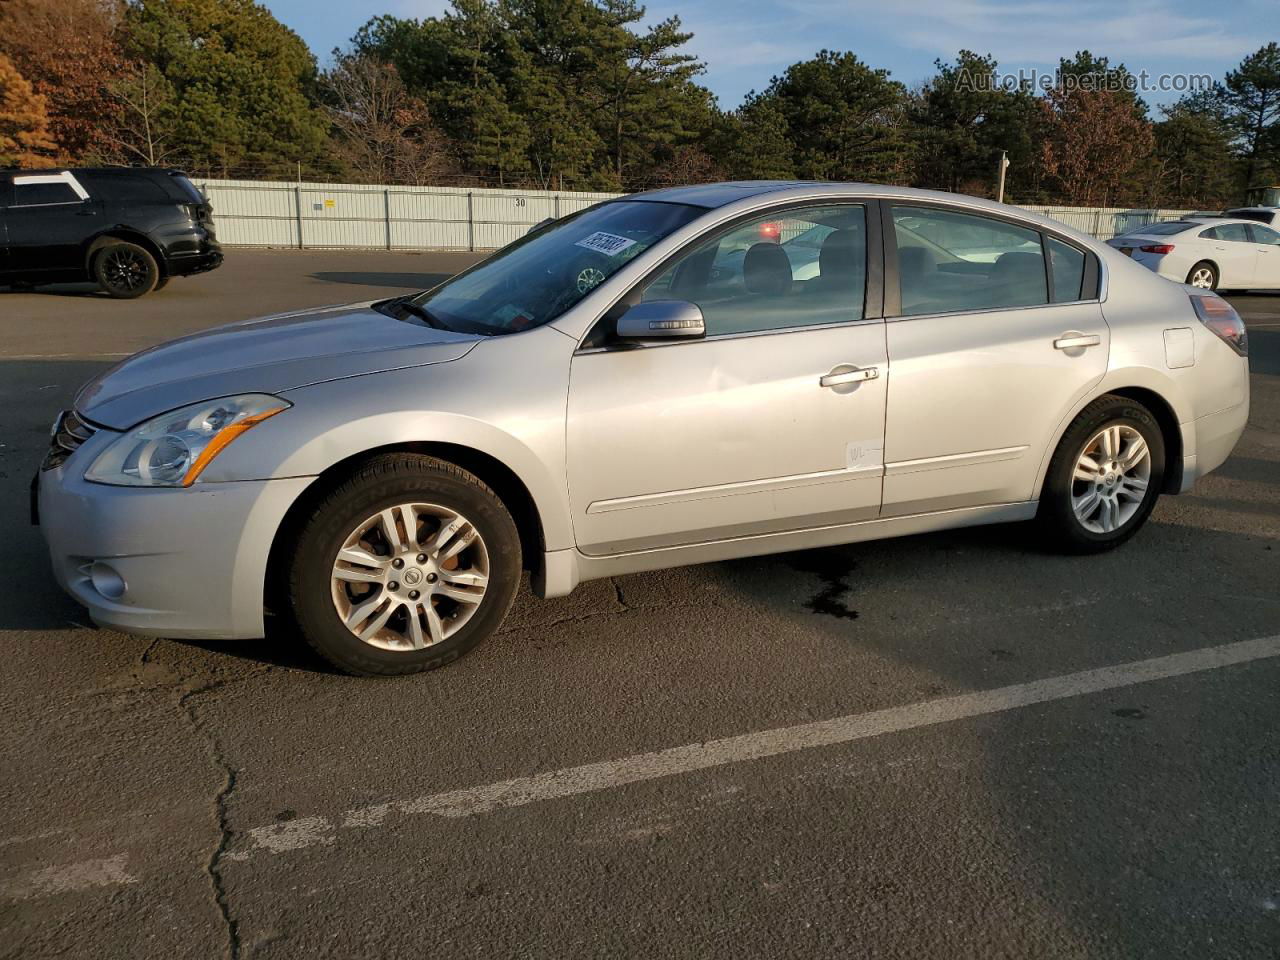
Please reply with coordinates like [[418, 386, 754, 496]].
[[406, 200, 707, 334]]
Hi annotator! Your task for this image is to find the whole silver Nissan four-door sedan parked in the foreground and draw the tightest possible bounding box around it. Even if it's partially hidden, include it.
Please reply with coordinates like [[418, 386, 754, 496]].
[[36, 183, 1249, 675]]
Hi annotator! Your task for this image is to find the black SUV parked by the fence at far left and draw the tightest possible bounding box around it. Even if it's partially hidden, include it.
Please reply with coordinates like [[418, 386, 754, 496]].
[[0, 168, 223, 298]]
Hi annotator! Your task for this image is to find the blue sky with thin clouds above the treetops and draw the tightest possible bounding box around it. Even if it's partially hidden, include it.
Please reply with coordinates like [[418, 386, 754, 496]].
[[260, 0, 1280, 109]]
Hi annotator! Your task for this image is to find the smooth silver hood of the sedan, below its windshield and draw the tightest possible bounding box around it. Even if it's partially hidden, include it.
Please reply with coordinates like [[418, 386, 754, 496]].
[[76, 303, 481, 430]]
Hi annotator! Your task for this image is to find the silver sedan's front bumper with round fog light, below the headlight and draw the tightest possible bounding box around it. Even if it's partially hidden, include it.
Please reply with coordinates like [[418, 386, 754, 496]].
[[37, 440, 314, 639]]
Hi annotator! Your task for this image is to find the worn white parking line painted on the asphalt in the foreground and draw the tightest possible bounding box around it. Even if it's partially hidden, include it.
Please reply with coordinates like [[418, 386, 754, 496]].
[[10, 635, 1280, 900]]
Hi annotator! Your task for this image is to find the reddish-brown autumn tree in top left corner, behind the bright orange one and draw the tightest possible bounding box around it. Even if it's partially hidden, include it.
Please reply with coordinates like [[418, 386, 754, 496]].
[[0, 0, 125, 163]]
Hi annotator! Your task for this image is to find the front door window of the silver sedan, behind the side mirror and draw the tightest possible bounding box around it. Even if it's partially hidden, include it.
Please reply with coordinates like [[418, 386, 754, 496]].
[[643, 204, 867, 337]]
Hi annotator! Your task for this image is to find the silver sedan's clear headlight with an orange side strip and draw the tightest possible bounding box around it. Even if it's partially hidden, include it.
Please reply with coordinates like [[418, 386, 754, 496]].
[[84, 393, 291, 486]]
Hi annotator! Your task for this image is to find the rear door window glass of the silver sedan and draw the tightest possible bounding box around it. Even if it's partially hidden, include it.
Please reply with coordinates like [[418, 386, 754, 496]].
[[893, 206, 1044, 316]]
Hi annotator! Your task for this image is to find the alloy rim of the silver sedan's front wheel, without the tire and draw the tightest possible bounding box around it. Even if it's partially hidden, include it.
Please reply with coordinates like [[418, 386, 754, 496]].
[[332, 503, 489, 650]]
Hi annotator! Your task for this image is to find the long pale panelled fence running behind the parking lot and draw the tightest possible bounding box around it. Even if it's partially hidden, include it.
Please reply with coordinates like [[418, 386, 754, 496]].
[[196, 179, 1190, 250]]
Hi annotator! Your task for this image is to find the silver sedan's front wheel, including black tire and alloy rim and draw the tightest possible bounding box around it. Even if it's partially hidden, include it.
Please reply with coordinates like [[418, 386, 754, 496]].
[[288, 454, 521, 676]]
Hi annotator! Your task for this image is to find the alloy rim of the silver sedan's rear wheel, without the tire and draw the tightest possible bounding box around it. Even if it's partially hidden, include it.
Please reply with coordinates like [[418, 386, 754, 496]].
[[1071, 424, 1151, 534]]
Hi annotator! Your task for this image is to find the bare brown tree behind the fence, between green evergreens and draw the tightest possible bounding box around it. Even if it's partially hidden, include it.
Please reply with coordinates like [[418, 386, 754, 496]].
[[324, 55, 453, 186]]
